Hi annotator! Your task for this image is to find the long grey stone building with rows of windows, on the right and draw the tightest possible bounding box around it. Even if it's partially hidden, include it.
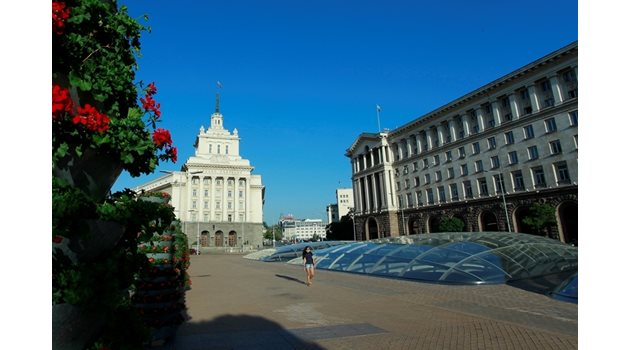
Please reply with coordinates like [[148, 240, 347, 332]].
[[346, 42, 578, 241]]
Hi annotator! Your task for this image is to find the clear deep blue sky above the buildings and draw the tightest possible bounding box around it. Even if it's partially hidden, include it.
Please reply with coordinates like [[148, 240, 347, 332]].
[[113, 0, 578, 223]]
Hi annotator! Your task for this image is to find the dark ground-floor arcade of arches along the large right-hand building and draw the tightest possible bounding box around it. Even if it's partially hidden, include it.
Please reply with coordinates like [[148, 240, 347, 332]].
[[356, 198, 578, 246]]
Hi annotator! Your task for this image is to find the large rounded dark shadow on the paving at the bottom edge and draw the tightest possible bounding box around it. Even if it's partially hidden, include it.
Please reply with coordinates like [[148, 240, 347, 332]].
[[147, 315, 324, 350]]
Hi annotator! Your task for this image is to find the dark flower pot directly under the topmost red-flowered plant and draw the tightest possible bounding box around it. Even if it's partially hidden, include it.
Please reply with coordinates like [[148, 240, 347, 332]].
[[53, 149, 123, 202]]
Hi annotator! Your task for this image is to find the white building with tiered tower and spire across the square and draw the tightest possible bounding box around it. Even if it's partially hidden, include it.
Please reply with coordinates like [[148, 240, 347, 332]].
[[134, 94, 265, 247]]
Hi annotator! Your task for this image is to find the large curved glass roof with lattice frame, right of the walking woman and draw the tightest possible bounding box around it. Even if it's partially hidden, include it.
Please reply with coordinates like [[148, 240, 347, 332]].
[[290, 232, 578, 298]]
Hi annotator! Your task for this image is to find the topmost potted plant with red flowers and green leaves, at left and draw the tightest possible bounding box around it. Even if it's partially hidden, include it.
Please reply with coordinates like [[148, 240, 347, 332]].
[[52, 0, 177, 200]]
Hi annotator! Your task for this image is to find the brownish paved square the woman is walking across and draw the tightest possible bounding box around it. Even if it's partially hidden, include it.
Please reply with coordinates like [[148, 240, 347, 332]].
[[151, 255, 578, 350]]
